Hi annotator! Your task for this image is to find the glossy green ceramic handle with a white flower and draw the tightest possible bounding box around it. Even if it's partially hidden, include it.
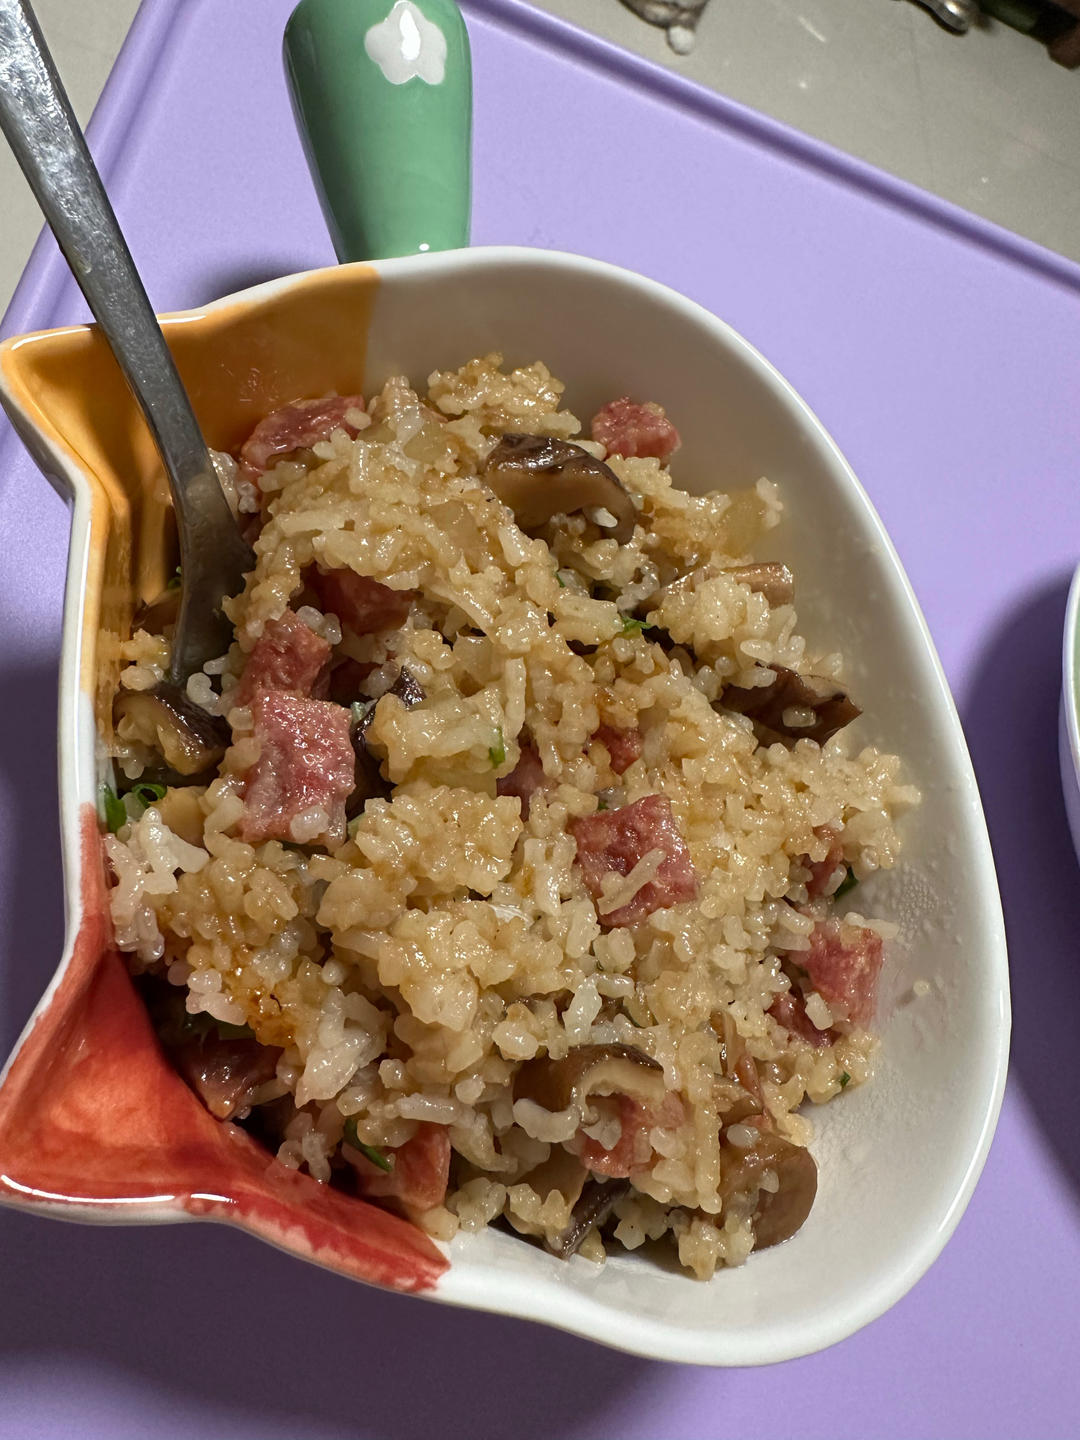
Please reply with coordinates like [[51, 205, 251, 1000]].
[[285, 0, 472, 261]]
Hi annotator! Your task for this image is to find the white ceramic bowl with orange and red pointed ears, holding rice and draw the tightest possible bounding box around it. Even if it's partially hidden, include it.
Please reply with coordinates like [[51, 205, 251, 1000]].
[[0, 249, 1009, 1365]]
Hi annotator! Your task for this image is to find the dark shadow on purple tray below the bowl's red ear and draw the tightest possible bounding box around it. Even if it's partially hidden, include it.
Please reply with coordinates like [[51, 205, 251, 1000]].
[[0, 1211, 660, 1440]]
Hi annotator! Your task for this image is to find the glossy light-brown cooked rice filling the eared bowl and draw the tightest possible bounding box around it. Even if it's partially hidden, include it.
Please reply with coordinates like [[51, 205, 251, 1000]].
[[105, 357, 917, 1277]]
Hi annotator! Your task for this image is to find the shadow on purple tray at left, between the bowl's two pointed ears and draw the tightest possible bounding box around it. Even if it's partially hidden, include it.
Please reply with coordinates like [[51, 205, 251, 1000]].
[[0, 649, 63, 1063]]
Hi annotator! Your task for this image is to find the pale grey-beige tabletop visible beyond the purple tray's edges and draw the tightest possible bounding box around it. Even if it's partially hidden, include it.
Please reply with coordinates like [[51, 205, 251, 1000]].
[[0, 0, 1080, 312]]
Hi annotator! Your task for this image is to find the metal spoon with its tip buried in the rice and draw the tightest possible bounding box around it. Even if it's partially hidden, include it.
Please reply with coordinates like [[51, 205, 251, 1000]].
[[0, 0, 255, 684]]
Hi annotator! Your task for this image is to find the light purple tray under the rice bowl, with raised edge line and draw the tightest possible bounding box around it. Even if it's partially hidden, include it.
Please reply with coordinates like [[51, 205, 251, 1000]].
[[0, 0, 1080, 1440]]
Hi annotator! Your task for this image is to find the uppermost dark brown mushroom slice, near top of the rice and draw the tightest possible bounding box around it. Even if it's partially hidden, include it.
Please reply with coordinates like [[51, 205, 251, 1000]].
[[482, 435, 638, 544]]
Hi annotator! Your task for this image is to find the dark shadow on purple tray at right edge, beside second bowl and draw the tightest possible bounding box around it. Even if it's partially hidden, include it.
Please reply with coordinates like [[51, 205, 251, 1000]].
[[962, 576, 1080, 1201]]
